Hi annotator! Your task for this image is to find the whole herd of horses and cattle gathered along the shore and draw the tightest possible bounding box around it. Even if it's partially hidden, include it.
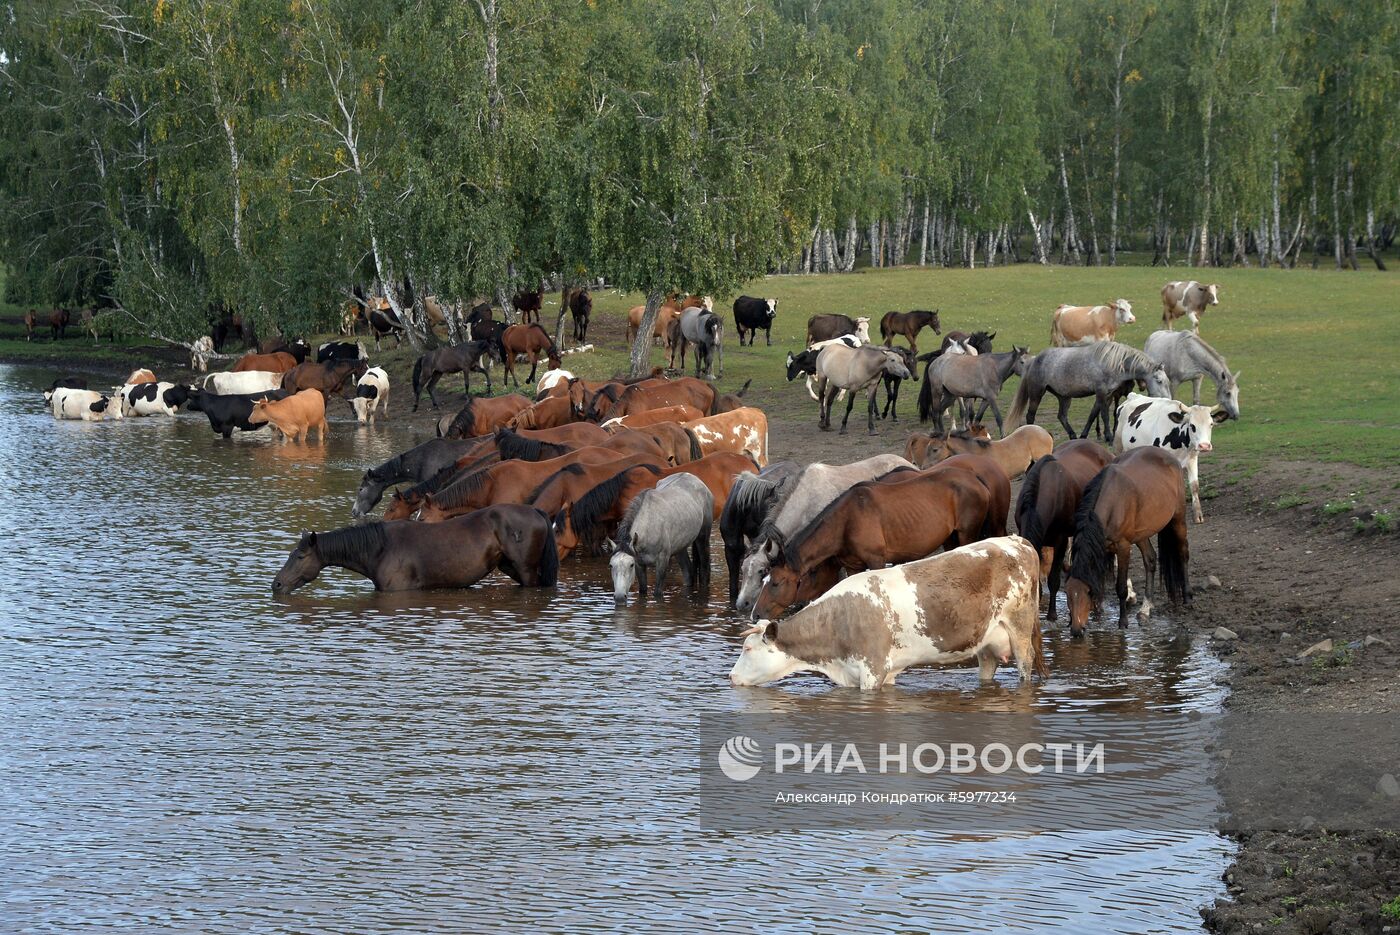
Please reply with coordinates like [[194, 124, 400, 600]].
[[35, 274, 1239, 689]]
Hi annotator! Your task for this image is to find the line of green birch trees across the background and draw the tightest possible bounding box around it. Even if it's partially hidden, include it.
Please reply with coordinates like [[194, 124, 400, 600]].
[[0, 0, 1400, 352]]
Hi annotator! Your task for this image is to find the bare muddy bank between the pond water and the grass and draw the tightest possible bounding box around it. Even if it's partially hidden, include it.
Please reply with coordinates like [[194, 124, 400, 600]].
[[0, 342, 1400, 934]]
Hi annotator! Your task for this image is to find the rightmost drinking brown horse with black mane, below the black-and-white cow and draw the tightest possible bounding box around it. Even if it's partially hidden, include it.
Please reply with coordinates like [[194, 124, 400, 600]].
[[1064, 448, 1191, 637]]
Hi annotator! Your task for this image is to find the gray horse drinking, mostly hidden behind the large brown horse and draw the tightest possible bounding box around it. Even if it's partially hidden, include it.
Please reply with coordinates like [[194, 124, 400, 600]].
[[734, 455, 914, 613]]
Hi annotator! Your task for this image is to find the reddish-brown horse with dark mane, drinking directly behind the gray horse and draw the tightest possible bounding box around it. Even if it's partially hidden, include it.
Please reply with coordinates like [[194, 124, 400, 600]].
[[554, 452, 757, 550]]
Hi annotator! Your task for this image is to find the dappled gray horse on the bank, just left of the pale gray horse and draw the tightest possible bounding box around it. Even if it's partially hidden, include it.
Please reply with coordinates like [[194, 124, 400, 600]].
[[1009, 342, 1172, 440]]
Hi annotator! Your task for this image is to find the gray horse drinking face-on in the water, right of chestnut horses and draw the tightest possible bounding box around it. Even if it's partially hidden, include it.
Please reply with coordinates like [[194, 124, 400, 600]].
[[609, 474, 714, 603]]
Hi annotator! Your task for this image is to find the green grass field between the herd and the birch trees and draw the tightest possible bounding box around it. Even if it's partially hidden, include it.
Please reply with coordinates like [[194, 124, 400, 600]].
[[0, 265, 1400, 468]]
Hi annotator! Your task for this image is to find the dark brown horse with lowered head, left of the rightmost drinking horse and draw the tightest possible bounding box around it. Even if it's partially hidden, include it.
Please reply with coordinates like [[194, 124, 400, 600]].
[[1012, 433, 1113, 620]]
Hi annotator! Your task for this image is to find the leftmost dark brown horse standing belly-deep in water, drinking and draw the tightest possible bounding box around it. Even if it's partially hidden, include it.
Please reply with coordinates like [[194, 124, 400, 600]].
[[272, 505, 559, 593]]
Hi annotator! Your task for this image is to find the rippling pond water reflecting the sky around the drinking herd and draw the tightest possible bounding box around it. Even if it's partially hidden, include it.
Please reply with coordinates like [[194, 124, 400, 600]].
[[0, 368, 1228, 932]]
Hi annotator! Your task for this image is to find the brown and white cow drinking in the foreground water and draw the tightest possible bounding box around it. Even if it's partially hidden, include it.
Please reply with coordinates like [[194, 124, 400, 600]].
[[729, 536, 1049, 691]]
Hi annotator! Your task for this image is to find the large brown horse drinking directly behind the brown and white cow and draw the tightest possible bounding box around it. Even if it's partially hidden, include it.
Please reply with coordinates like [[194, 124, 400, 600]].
[[753, 465, 1005, 620]]
